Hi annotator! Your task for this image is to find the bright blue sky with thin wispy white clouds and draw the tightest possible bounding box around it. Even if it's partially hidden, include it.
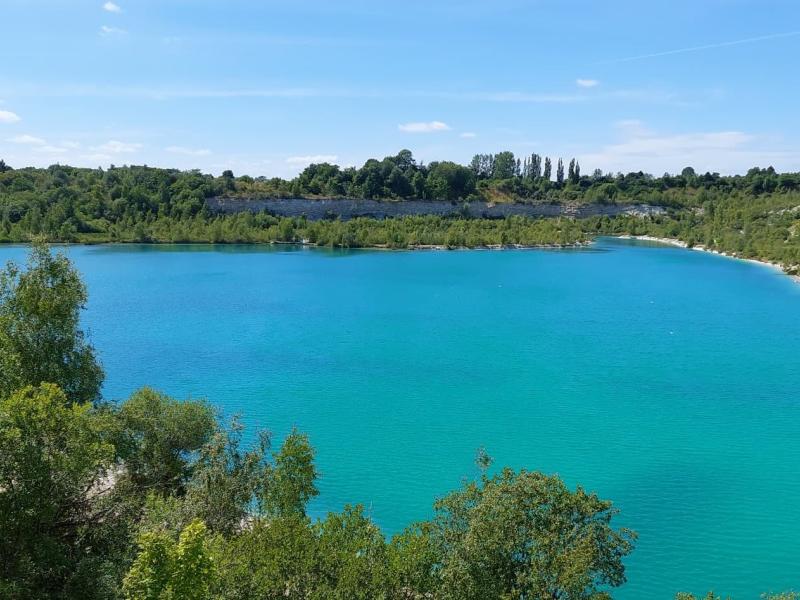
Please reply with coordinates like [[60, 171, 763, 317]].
[[0, 0, 800, 176]]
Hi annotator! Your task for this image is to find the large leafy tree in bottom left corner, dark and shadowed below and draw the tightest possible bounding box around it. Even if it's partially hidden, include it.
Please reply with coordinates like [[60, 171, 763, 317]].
[[0, 383, 114, 599]]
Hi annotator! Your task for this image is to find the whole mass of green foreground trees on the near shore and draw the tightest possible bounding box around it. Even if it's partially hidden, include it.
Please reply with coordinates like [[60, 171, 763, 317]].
[[0, 242, 797, 600]]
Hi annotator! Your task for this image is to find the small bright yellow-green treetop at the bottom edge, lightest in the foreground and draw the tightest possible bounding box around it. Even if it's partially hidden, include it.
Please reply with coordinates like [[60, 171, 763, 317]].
[[122, 521, 217, 600]]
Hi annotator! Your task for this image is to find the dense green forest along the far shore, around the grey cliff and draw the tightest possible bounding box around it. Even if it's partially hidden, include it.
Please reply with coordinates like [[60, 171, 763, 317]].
[[0, 150, 800, 272]]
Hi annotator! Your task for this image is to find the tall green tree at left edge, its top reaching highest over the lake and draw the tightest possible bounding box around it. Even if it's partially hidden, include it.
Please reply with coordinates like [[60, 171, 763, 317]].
[[0, 241, 103, 402]]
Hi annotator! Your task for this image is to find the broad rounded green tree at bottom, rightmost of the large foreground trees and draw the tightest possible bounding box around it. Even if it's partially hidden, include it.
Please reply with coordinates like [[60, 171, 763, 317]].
[[431, 469, 635, 600]]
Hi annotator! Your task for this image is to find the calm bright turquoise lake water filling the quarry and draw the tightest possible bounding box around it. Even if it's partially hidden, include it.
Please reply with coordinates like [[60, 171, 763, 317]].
[[0, 240, 800, 600]]
